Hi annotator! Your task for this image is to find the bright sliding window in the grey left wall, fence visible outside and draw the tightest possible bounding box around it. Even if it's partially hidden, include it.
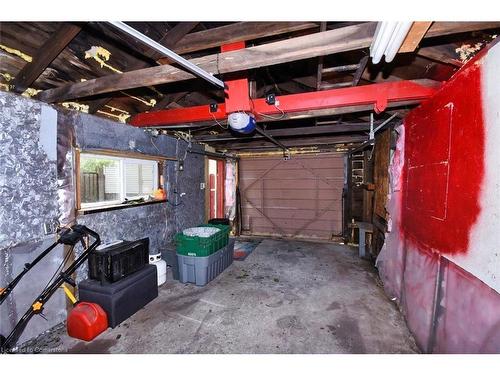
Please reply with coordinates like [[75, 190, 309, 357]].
[[80, 153, 159, 209]]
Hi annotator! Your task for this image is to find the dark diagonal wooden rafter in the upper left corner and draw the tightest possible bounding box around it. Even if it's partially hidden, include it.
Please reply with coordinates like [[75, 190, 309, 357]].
[[12, 23, 82, 93]]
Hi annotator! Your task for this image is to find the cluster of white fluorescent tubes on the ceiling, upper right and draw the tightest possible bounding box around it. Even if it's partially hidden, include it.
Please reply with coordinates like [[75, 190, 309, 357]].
[[370, 21, 413, 64]]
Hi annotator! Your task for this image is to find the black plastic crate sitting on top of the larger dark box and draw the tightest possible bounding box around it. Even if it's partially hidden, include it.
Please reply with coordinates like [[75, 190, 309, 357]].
[[89, 237, 149, 282]]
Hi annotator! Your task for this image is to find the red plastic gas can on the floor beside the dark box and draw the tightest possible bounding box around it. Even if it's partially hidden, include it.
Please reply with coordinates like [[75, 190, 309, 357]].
[[66, 302, 108, 341]]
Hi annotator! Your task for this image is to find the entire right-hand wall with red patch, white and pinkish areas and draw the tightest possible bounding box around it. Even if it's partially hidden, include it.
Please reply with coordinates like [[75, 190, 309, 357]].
[[377, 43, 500, 353]]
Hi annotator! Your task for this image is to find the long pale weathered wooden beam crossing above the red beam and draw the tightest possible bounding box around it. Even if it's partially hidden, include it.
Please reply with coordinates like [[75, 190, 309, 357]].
[[38, 23, 376, 102]]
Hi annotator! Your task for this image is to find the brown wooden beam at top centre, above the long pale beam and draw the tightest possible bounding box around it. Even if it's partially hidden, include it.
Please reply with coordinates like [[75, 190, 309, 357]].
[[161, 22, 318, 54]]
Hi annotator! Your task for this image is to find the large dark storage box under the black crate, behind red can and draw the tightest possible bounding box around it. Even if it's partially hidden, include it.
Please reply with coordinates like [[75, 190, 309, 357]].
[[78, 264, 158, 328]]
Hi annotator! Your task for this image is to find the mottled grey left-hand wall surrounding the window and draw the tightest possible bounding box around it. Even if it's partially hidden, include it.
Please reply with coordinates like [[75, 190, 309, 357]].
[[0, 93, 204, 342]]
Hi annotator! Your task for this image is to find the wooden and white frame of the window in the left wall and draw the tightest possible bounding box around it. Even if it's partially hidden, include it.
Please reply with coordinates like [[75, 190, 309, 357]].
[[74, 149, 165, 213]]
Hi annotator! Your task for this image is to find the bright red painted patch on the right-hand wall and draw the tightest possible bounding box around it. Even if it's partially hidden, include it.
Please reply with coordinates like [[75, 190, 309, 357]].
[[401, 63, 484, 254]]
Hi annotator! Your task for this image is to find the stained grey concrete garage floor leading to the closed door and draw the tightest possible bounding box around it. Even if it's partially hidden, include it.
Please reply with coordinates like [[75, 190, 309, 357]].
[[26, 239, 418, 353]]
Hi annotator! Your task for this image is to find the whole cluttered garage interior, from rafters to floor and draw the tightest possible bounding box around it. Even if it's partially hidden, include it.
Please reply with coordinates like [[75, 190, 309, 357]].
[[0, 21, 500, 354]]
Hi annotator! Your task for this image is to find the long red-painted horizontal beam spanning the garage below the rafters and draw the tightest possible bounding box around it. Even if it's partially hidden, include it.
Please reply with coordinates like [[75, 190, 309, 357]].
[[130, 81, 437, 127]]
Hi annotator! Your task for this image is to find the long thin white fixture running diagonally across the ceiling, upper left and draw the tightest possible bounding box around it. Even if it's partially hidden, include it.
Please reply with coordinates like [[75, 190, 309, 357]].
[[109, 21, 224, 89]]
